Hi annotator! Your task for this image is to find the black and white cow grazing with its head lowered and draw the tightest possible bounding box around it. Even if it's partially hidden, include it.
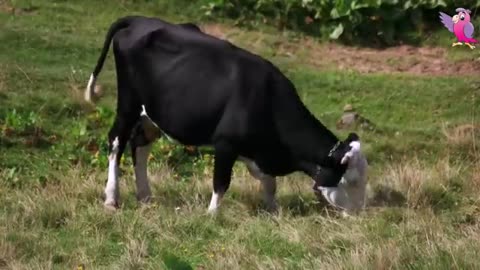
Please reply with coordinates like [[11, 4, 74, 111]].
[[85, 16, 359, 212]]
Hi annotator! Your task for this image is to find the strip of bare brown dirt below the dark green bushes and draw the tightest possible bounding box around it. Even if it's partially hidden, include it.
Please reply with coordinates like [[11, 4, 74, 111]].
[[202, 24, 480, 75]]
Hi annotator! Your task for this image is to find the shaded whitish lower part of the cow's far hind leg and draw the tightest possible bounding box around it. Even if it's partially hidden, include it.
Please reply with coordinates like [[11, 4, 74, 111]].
[[135, 144, 152, 202]]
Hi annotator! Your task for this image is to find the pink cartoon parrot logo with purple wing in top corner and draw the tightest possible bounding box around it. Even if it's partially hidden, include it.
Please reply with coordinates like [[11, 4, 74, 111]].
[[440, 8, 478, 50]]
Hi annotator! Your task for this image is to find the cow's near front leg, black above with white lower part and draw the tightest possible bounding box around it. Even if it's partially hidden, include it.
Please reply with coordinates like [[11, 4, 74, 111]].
[[208, 143, 237, 213]]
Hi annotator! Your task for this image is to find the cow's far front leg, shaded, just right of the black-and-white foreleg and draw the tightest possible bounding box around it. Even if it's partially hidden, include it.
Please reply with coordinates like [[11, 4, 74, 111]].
[[242, 159, 277, 212]]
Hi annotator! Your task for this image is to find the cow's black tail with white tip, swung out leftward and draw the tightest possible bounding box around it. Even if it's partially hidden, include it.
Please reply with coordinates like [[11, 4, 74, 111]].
[[84, 17, 133, 102]]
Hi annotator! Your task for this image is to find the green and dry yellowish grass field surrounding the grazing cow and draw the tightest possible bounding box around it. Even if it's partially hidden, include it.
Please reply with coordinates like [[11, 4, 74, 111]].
[[0, 0, 480, 269]]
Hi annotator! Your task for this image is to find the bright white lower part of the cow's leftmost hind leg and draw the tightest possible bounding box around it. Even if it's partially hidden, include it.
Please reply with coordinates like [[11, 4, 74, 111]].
[[104, 137, 120, 207]]
